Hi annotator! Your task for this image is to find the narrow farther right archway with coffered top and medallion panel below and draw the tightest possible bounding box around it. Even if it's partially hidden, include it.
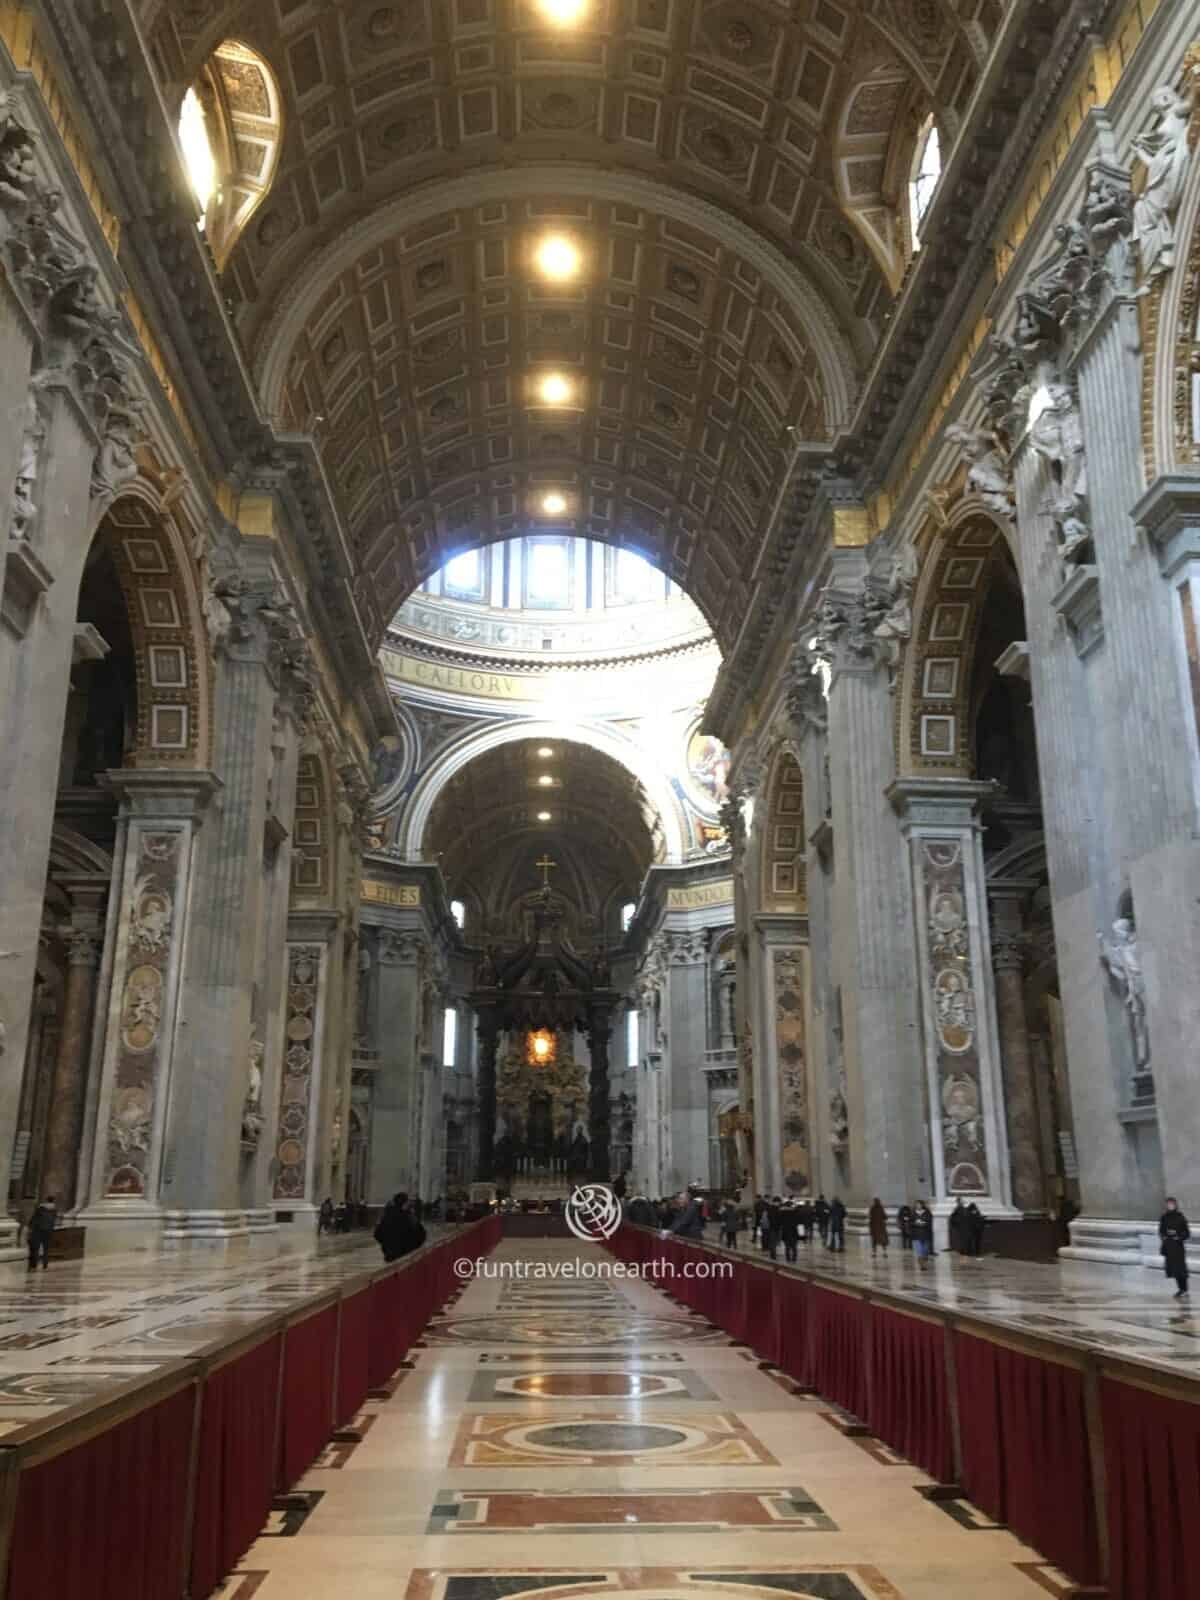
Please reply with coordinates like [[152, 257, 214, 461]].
[[755, 744, 813, 1194]]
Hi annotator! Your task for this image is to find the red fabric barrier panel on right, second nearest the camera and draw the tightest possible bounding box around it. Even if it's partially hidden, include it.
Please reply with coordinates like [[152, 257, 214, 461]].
[[955, 1333, 1120, 1594]]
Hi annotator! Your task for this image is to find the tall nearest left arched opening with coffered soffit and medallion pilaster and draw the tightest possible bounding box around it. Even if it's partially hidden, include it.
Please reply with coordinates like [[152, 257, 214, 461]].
[[18, 475, 211, 1211]]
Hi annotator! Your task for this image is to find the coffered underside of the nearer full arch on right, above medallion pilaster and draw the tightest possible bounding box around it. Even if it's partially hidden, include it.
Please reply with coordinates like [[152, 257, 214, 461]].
[[896, 499, 1011, 778]]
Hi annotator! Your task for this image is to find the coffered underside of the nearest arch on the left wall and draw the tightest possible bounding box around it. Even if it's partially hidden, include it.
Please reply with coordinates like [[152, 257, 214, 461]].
[[96, 483, 211, 768]]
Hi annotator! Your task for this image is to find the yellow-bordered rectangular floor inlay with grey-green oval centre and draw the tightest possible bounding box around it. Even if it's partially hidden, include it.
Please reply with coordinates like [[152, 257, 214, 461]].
[[450, 1411, 779, 1467]]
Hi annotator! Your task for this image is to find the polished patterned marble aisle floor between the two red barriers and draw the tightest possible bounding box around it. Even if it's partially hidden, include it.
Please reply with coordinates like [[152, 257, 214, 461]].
[[230, 1240, 1094, 1600]]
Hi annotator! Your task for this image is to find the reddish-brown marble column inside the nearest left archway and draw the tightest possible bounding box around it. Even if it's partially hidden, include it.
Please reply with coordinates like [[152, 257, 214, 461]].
[[42, 908, 107, 1213]]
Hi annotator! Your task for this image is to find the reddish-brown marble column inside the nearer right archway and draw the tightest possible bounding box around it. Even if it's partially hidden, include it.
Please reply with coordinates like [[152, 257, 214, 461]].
[[989, 890, 1046, 1214]]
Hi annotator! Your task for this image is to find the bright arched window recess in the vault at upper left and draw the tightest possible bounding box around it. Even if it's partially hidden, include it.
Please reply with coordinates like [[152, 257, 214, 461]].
[[179, 38, 283, 269]]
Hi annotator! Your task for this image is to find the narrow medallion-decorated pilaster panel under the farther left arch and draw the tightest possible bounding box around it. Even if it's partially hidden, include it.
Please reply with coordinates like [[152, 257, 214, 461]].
[[275, 944, 326, 1205]]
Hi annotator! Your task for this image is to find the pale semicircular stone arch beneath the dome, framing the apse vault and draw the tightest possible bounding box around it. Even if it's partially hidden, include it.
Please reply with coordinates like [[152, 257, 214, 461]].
[[397, 718, 686, 862]]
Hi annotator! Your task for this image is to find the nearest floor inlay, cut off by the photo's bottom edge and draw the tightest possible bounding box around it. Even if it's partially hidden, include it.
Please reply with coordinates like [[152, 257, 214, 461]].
[[405, 1565, 902, 1600]]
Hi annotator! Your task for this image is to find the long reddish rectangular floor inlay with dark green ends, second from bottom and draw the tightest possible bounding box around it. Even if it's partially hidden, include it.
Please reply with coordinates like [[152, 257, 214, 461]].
[[427, 1488, 837, 1533]]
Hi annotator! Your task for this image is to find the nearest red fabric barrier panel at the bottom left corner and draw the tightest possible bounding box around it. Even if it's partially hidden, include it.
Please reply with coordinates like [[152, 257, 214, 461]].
[[8, 1384, 195, 1600]]
